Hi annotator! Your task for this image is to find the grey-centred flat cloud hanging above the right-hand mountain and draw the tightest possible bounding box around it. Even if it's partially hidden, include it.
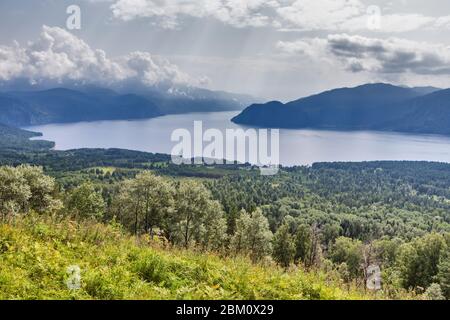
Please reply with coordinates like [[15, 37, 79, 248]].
[[277, 34, 450, 75]]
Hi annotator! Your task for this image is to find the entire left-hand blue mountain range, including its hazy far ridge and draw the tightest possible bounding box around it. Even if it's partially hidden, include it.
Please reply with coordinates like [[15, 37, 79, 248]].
[[0, 86, 251, 126]]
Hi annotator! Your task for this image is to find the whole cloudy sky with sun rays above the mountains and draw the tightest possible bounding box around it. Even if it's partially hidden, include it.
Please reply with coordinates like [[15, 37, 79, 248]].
[[0, 0, 450, 101]]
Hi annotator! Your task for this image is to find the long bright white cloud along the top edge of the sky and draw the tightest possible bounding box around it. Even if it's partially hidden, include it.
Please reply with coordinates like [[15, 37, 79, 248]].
[[111, 0, 450, 32]]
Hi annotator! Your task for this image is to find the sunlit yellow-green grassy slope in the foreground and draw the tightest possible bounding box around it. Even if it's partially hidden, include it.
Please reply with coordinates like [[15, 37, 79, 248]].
[[0, 216, 384, 300]]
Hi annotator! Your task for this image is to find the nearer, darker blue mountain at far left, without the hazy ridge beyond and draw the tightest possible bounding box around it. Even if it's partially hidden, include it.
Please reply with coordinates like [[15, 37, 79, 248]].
[[0, 88, 162, 126]]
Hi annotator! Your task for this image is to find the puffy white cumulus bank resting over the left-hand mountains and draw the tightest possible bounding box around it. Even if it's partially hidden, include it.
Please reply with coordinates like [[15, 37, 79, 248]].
[[0, 26, 204, 86]]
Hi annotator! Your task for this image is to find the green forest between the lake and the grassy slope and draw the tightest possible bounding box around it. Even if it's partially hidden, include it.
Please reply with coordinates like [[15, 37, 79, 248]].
[[0, 149, 450, 299]]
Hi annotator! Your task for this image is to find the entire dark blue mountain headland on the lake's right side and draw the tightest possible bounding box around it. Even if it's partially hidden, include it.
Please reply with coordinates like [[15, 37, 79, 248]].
[[232, 83, 450, 134]]
